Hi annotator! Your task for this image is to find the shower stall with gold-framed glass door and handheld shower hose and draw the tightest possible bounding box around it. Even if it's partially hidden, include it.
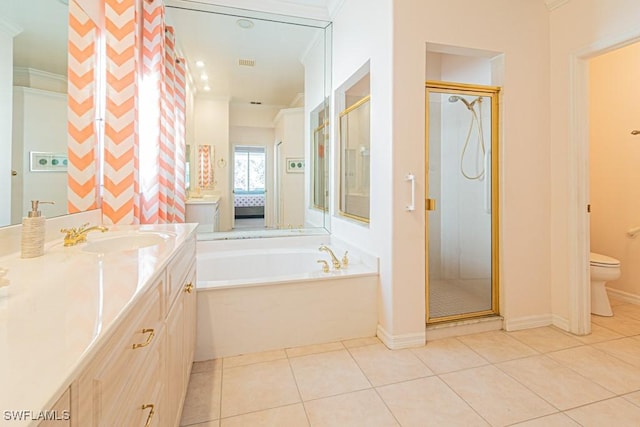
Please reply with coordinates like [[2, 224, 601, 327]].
[[426, 82, 499, 323]]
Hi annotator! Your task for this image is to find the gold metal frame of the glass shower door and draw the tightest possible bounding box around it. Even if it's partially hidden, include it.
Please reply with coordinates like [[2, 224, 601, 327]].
[[425, 80, 500, 324]]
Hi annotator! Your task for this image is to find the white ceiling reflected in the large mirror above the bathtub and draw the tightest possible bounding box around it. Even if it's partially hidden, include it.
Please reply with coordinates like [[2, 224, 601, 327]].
[[166, 0, 323, 106]]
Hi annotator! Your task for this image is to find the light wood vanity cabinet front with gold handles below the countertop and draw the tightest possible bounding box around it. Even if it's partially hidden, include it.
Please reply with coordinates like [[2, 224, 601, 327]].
[[71, 237, 195, 427]]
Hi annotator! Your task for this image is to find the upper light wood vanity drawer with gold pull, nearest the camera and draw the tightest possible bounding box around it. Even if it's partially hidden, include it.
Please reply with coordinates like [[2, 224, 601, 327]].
[[78, 276, 165, 425]]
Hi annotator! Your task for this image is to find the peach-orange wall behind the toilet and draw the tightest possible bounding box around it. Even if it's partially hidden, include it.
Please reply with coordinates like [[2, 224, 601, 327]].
[[589, 43, 640, 298]]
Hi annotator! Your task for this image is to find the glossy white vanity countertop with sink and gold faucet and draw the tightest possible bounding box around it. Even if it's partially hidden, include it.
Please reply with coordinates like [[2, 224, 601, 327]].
[[0, 224, 196, 426]]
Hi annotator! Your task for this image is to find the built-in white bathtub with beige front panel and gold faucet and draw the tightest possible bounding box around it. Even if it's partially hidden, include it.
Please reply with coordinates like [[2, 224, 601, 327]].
[[195, 236, 378, 361]]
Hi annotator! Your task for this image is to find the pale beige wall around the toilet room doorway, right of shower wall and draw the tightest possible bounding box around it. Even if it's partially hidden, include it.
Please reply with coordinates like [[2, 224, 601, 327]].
[[549, 0, 640, 326]]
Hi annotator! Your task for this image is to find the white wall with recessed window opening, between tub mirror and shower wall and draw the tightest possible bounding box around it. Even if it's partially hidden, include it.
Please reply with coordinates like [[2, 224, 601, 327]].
[[330, 0, 396, 340]]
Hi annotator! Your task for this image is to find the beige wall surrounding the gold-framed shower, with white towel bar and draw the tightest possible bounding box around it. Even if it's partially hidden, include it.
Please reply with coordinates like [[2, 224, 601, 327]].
[[390, 0, 551, 342]]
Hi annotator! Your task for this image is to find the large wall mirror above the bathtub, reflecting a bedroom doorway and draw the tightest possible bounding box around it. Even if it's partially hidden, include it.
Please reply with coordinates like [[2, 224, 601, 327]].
[[166, 0, 331, 238]]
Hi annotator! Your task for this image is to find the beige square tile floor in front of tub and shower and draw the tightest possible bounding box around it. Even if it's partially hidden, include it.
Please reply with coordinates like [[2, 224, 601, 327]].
[[181, 302, 640, 427]]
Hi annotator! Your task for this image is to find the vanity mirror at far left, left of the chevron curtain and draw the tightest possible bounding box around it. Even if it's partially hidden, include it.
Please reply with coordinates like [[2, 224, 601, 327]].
[[0, 0, 77, 226]]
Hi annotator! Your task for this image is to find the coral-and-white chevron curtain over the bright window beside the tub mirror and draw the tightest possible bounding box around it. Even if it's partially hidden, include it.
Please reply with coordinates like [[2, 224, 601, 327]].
[[102, 0, 186, 224]]
